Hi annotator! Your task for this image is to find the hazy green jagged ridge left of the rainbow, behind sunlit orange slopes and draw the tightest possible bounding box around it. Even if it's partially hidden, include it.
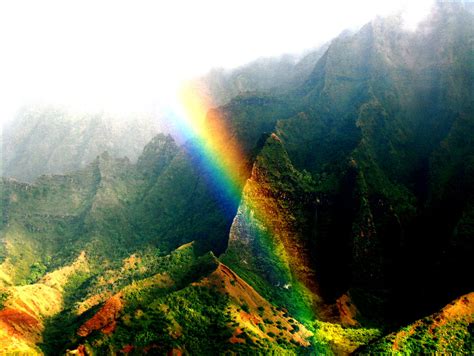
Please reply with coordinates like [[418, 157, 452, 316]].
[[0, 134, 237, 285]]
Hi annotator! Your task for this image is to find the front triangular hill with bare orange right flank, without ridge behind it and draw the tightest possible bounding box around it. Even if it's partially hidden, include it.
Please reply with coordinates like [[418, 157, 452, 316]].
[[59, 246, 311, 354]]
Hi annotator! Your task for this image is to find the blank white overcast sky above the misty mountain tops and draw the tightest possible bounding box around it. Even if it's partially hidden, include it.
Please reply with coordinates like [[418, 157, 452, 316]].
[[0, 0, 432, 121]]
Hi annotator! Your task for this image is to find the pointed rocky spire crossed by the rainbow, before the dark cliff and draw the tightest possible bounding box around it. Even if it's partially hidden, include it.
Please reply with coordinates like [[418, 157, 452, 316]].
[[223, 134, 321, 320]]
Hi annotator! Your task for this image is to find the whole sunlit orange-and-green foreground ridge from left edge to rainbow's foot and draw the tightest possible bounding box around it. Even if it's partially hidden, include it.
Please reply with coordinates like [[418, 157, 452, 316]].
[[0, 243, 312, 354]]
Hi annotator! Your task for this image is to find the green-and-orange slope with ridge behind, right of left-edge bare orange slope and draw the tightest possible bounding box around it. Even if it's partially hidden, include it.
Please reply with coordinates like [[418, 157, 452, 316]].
[[41, 244, 311, 354]]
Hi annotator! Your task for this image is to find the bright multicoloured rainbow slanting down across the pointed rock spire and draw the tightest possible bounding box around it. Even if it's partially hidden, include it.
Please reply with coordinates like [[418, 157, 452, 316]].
[[173, 80, 314, 320]]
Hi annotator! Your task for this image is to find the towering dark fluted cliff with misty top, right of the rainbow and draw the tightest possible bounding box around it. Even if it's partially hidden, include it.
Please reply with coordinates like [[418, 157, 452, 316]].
[[218, 0, 474, 322]]
